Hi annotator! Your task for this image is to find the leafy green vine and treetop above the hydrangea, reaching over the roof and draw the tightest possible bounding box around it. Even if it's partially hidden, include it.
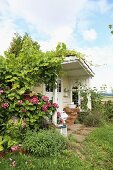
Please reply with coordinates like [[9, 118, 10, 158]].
[[0, 34, 83, 93]]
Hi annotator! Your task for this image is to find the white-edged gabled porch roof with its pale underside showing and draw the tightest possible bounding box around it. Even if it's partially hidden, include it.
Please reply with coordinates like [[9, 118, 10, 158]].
[[62, 56, 94, 77]]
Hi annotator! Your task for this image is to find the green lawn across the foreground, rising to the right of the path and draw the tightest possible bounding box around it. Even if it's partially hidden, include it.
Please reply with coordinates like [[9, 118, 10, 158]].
[[0, 124, 113, 170]]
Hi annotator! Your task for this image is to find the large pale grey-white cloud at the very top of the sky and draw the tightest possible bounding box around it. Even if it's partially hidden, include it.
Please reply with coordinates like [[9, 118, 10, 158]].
[[8, 0, 88, 33]]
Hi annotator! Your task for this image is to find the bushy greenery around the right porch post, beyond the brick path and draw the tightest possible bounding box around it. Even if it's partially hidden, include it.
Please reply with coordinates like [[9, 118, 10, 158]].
[[78, 88, 113, 126]]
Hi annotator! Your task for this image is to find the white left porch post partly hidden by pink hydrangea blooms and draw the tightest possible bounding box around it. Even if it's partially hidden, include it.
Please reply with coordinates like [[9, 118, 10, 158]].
[[52, 83, 57, 125]]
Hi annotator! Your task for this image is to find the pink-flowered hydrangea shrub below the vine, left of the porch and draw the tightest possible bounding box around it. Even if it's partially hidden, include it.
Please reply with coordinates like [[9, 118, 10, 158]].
[[0, 88, 58, 151]]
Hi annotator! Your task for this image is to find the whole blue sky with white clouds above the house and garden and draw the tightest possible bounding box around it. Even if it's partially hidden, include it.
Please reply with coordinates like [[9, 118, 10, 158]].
[[0, 0, 113, 91]]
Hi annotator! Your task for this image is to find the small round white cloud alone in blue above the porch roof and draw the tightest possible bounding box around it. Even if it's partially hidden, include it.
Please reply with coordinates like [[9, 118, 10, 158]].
[[83, 29, 97, 41]]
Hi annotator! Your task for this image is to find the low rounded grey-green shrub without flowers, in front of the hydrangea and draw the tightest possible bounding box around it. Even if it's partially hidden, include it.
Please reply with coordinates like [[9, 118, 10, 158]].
[[22, 129, 67, 156]]
